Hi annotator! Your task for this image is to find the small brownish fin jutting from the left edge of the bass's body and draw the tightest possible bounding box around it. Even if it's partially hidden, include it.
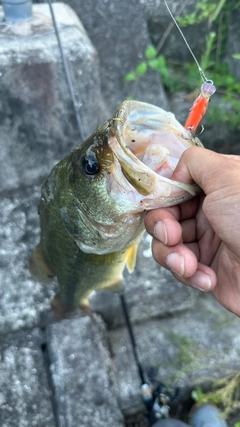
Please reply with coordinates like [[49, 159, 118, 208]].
[[28, 243, 54, 283]]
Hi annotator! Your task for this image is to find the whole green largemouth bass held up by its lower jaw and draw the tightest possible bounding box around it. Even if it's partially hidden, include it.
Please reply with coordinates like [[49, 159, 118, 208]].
[[30, 101, 201, 311]]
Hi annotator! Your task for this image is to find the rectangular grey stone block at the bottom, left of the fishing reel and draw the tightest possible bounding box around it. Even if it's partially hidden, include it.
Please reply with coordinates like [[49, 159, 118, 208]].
[[47, 317, 124, 427]]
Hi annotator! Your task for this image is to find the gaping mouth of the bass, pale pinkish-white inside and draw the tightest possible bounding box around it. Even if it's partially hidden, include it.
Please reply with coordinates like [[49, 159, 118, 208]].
[[109, 101, 202, 209]]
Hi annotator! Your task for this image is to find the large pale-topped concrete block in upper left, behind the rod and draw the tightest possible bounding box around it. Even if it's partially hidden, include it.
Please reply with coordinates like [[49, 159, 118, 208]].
[[0, 3, 107, 191]]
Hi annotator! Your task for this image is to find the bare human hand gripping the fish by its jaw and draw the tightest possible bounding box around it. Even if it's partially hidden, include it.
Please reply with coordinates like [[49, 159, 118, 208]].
[[145, 147, 240, 316]]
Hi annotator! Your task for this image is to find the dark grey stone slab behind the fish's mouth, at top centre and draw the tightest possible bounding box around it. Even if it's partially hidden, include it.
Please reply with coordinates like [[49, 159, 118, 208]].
[[64, 0, 168, 115]]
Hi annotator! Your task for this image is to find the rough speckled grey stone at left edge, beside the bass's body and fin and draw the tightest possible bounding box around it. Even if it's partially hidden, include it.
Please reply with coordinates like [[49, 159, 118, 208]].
[[0, 187, 56, 334]]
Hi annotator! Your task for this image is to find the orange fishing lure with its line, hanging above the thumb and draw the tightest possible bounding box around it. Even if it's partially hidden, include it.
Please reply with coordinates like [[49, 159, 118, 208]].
[[164, 0, 216, 133]]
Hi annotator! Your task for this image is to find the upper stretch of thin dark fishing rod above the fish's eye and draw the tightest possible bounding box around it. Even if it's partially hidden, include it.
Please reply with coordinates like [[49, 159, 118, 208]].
[[47, 0, 85, 141]]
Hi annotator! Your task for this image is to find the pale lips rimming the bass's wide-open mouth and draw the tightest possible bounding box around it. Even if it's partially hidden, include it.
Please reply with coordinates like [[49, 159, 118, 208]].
[[109, 101, 202, 197]]
